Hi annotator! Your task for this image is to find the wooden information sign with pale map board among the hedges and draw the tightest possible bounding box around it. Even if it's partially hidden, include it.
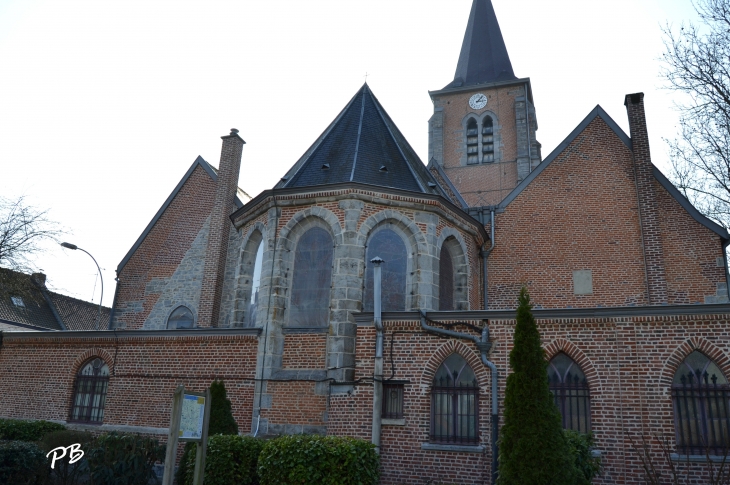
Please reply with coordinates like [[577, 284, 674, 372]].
[[162, 385, 210, 485]]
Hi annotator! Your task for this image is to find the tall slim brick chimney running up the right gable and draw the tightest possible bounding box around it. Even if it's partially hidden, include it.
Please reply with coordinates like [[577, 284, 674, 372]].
[[624, 93, 668, 305]]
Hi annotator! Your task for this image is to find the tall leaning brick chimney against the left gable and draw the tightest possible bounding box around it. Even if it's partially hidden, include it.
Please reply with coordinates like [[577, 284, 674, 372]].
[[198, 128, 246, 327]]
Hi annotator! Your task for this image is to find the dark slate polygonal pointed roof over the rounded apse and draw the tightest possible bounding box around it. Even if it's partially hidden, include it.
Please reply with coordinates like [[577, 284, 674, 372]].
[[276, 83, 442, 195]]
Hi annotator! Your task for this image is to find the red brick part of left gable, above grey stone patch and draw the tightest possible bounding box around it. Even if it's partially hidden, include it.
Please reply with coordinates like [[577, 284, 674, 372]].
[[114, 167, 215, 330]]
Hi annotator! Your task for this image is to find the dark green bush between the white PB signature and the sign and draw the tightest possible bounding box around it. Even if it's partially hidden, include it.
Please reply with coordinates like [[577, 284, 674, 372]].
[[85, 432, 165, 485]]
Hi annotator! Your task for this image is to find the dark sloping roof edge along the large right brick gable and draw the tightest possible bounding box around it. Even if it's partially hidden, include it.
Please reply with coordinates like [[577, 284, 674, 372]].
[[499, 105, 730, 241]]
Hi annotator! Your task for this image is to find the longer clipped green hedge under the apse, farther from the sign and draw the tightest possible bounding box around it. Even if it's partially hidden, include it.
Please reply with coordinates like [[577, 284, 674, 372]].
[[259, 435, 380, 485]]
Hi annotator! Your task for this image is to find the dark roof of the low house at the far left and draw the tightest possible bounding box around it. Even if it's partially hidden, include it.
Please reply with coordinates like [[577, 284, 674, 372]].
[[0, 268, 111, 331]]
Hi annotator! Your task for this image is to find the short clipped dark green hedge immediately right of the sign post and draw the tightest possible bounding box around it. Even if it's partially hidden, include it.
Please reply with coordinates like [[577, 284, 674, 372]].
[[185, 434, 264, 485]]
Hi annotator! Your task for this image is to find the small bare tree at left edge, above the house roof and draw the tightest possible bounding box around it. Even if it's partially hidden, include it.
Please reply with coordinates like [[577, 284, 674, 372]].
[[0, 196, 63, 299]]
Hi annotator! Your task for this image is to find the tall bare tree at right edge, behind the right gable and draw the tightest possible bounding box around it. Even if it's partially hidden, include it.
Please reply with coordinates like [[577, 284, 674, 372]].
[[662, 0, 730, 227]]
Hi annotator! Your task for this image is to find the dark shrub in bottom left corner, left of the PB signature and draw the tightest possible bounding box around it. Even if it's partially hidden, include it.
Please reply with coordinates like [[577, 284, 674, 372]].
[[0, 441, 46, 485]]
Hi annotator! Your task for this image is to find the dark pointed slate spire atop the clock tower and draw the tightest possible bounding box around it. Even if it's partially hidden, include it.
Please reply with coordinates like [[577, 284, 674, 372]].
[[446, 0, 517, 88]]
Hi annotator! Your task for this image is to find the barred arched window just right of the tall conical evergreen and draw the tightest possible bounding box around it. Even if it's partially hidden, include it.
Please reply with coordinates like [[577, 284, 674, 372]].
[[548, 353, 591, 433]]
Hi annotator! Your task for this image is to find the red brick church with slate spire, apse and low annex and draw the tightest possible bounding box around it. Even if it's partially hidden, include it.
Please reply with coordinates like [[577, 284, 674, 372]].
[[0, 0, 730, 485]]
